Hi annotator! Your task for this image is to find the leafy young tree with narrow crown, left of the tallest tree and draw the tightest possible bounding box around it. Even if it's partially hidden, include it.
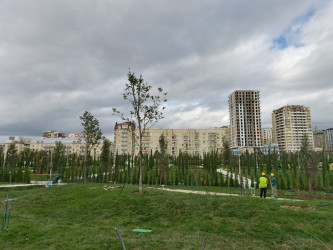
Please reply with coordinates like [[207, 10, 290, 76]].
[[80, 111, 102, 183]]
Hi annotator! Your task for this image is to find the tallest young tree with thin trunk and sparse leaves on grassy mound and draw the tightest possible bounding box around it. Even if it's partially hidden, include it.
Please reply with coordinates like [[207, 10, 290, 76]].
[[113, 71, 167, 194]]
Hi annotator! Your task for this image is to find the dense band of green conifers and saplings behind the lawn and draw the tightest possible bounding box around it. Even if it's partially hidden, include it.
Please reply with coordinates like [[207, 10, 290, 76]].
[[0, 135, 333, 195]]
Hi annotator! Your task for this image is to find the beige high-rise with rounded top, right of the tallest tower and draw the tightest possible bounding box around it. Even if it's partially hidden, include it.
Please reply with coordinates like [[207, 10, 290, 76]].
[[272, 105, 313, 152]]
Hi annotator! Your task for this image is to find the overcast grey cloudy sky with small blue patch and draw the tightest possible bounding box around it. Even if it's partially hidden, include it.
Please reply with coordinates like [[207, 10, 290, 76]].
[[0, 0, 333, 142]]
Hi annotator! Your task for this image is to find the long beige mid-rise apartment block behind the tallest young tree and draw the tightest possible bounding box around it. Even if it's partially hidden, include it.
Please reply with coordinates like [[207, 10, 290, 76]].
[[114, 123, 230, 156]]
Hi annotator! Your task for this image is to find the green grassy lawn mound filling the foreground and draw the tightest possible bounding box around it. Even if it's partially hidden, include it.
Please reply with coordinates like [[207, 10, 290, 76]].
[[0, 184, 333, 249]]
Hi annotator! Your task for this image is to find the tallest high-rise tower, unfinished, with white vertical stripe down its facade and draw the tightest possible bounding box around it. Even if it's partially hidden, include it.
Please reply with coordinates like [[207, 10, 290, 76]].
[[229, 90, 262, 148]]
